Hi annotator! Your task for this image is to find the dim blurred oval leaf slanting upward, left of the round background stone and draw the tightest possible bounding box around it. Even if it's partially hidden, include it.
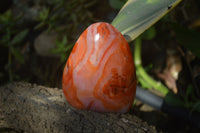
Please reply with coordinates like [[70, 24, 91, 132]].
[[10, 29, 29, 45]]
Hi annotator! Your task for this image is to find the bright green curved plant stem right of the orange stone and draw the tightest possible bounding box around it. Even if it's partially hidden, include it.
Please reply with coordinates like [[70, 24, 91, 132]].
[[134, 38, 169, 95]]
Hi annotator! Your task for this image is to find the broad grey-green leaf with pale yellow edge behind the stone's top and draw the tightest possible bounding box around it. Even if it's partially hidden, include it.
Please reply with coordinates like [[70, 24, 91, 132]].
[[112, 0, 181, 42]]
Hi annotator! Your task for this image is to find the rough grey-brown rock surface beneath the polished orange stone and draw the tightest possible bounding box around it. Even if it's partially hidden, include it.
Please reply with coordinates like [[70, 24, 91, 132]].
[[0, 82, 156, 133]]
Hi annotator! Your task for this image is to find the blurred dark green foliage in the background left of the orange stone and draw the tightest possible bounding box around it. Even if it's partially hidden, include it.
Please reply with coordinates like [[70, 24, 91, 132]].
[[0, 0, 97, 83]]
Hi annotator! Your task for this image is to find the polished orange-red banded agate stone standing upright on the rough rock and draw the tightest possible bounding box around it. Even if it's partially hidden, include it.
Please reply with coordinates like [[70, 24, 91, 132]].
[[62, 22, 136, 113]]
